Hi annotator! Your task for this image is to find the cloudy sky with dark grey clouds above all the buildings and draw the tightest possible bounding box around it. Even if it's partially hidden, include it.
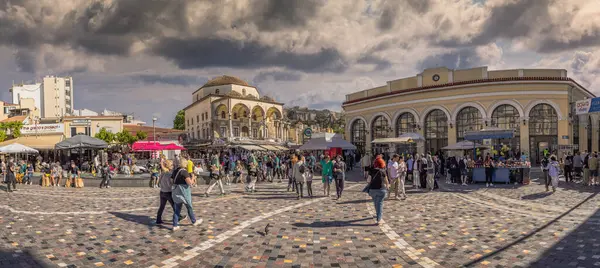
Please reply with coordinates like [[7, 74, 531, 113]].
[[0, 0, 600, 126]]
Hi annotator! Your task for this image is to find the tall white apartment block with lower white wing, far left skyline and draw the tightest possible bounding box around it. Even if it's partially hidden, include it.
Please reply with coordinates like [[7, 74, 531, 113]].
[[10, 76, 73, 118]]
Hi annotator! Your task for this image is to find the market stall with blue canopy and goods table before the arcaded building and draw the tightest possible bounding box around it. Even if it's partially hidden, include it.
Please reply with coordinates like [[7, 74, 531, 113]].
[[465, 128, 531, 183]]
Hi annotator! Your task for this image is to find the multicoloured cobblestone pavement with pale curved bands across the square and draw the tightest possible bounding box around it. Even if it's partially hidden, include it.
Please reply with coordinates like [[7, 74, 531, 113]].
[[0, 173, 600, 267]]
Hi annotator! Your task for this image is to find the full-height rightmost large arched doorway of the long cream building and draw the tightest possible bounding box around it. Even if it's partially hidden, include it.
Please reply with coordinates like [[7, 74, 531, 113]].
[[529, 103, 558, 163]]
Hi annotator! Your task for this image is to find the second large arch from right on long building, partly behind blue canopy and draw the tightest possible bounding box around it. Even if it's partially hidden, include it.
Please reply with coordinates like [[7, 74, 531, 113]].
[[491, 104, 521, 152]]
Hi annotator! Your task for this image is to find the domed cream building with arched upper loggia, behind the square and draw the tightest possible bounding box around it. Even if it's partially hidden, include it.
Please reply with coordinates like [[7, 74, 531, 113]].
[[184, 75, 289, 141]]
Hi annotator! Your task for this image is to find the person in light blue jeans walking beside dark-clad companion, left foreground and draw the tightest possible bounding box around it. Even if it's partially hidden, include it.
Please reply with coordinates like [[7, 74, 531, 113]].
[[171, 159, 202, 231]]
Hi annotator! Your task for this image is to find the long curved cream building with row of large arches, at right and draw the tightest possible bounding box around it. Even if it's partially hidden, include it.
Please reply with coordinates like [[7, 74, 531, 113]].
[[342, 67, 600, 162]]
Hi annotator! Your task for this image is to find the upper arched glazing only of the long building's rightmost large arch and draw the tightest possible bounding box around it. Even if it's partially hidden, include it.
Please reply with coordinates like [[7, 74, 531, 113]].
[[529, 104, 558, 137]]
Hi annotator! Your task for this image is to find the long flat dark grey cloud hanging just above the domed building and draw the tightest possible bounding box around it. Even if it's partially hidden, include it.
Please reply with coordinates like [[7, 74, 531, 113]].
[[152, 38, 347, 72]]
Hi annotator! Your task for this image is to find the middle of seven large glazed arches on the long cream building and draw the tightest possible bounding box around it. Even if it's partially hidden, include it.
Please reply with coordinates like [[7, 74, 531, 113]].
[[425, 109, 448, 153]]
